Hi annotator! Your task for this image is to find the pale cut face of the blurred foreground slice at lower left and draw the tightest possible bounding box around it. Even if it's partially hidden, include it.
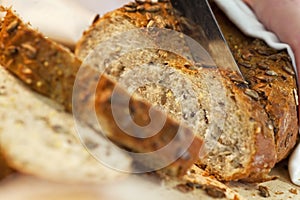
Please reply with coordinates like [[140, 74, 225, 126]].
[[0, 11, 131, 182]]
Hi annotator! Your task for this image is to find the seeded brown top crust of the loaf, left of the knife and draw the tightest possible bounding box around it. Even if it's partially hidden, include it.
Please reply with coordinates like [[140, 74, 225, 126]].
[[75, 0, 180, 59]]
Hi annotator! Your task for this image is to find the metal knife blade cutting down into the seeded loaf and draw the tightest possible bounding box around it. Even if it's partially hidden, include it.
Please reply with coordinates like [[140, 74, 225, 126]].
[[171, 0, 243, 79]]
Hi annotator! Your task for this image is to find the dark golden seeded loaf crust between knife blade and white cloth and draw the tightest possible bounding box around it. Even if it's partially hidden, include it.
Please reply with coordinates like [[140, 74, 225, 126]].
[[213, 3, 298, 162]]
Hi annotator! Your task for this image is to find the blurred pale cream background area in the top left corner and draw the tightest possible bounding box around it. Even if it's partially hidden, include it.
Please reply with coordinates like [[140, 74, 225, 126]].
[[0, 0, 128, 47]]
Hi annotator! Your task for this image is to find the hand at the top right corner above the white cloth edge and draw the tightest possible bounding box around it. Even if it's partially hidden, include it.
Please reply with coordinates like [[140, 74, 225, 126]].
[[243, 0, 300, 78]]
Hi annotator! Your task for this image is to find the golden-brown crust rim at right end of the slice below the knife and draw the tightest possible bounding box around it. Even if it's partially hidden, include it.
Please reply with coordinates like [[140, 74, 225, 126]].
[[198, 71, 277, 182]]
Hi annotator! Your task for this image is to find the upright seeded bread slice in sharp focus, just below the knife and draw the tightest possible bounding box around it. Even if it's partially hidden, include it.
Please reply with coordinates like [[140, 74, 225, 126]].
[[76, 1, 276, 181]]
